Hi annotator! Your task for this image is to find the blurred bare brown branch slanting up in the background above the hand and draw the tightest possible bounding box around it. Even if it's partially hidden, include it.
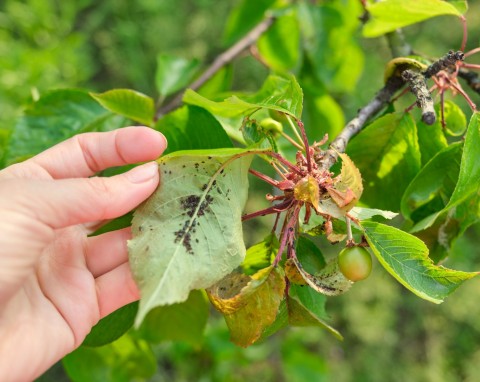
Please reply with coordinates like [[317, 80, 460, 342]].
[[155, 16, 275, 120]]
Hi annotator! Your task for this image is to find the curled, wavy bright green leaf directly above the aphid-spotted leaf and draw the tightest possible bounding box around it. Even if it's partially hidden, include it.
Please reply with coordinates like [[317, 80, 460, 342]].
[[183, 75, 303, 119]]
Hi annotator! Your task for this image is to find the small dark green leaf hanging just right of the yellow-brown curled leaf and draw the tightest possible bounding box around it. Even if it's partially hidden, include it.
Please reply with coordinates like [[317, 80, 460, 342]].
[[287, 284, 343, 340]]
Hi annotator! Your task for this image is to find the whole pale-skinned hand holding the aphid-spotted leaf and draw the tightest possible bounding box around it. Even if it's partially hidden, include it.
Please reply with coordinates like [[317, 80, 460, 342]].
[[0, 127, 166, 381]]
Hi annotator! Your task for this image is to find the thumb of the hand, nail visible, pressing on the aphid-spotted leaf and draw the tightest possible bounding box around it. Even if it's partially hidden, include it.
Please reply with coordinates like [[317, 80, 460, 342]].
[[15, 162, 159, 229]]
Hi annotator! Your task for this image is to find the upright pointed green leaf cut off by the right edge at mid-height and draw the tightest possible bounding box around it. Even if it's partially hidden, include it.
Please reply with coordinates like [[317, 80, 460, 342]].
[[445, 112, 480, 209]]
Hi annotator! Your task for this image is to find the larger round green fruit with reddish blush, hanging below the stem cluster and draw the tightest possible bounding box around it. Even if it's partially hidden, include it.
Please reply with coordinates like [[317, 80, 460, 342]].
[[338, 247, 372, 281]]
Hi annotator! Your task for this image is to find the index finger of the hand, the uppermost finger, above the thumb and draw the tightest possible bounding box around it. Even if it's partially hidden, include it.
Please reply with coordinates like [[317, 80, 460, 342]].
[[28, 126, 167, 179]]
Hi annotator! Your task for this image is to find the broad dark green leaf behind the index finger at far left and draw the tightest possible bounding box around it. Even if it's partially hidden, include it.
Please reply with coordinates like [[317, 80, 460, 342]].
[[5, 89, 125, 165]]
